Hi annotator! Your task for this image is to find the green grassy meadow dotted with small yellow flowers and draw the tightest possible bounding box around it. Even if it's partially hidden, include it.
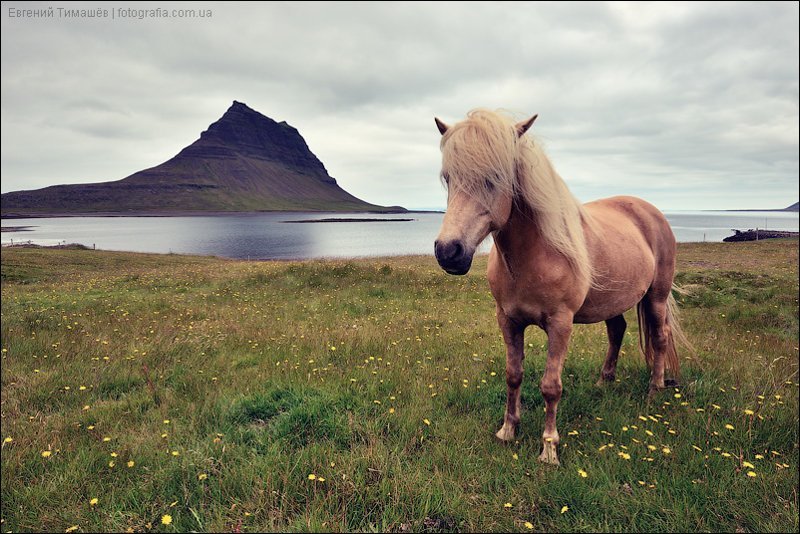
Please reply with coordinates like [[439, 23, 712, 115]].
[[2, 240, 798, 532]]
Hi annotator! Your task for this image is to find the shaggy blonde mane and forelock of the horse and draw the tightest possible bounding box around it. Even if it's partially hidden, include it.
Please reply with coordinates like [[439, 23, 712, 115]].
[[441, 109, 594, 284]]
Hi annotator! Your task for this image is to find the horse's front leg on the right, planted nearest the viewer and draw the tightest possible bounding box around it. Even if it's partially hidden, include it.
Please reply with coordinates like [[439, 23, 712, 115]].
[[539, 314, 572, 465]]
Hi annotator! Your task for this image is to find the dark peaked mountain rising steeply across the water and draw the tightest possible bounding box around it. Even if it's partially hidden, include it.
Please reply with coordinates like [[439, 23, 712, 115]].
[[2, 101, 406, 217]]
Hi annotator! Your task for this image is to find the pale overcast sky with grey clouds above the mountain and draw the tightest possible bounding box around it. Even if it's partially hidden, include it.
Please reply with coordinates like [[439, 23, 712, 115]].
[[0, 2, 799, 210]]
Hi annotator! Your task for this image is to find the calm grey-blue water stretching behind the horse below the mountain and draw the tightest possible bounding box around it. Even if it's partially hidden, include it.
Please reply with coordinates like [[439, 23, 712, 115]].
[[2, 211, 800, 259]]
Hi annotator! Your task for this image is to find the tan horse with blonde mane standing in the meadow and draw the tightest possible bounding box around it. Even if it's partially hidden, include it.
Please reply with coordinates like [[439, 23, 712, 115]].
[[435, 110, 685, 464]]
